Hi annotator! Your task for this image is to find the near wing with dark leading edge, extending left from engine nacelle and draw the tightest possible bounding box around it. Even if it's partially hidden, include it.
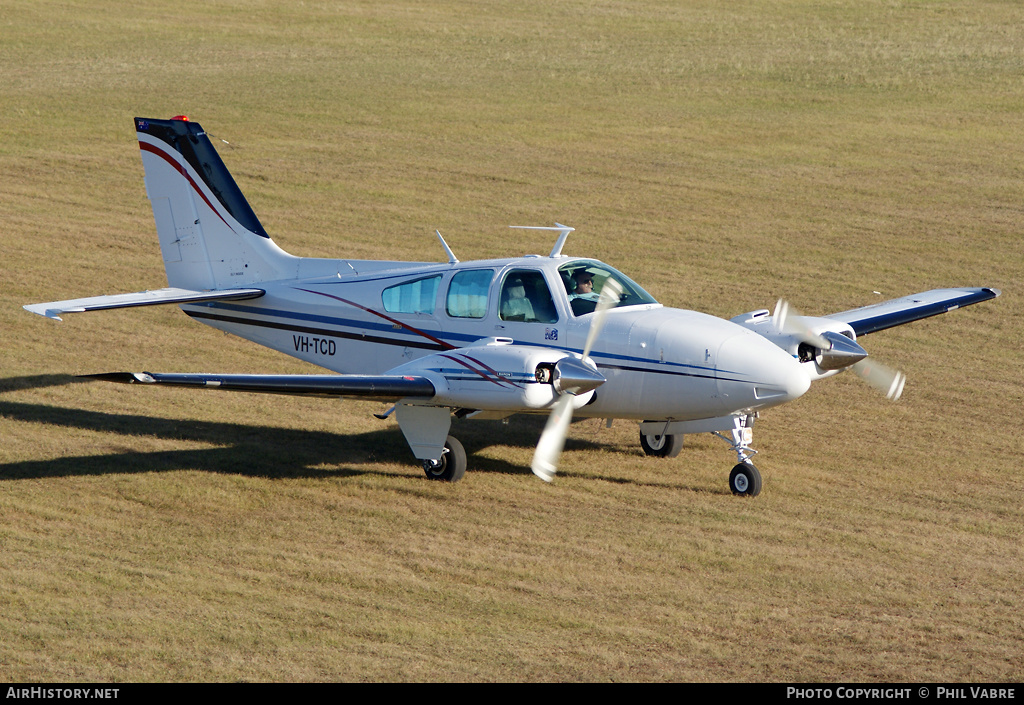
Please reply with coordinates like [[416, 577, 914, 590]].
[[82, 372, 434, 402]]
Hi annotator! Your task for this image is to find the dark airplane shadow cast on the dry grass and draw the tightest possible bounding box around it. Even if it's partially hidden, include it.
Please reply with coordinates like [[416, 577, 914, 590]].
[[0, 375, 627, 482]]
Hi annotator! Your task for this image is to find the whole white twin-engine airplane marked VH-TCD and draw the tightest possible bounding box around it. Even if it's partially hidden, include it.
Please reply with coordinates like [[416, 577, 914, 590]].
[[25, 116, 999, 496]]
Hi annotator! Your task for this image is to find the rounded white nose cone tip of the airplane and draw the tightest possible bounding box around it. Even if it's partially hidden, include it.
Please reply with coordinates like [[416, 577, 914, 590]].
[[716, 333, 811, 408]]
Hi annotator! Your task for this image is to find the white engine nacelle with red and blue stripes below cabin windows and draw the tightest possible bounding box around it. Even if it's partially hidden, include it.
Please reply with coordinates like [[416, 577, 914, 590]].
[[389, 338, 604, 413]]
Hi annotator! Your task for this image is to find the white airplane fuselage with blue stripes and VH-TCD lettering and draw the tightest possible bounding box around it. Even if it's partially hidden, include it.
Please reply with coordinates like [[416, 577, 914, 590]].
[[182, 256, 810, 420]]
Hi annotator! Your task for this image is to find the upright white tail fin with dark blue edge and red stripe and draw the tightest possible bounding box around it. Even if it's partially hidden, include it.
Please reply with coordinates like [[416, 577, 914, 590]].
[[135, 117, 295, 290]]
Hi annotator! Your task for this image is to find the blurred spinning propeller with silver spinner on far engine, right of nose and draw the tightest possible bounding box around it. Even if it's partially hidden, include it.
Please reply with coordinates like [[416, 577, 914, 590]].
[[772, 299, 906, 402]]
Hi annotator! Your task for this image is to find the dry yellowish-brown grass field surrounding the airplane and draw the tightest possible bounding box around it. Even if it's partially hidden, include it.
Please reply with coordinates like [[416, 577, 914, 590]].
[[0, 0, 1024, 682]]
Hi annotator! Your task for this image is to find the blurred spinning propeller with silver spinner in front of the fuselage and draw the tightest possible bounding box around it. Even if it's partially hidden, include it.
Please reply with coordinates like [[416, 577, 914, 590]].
[[530, 278, 623, 483]]
